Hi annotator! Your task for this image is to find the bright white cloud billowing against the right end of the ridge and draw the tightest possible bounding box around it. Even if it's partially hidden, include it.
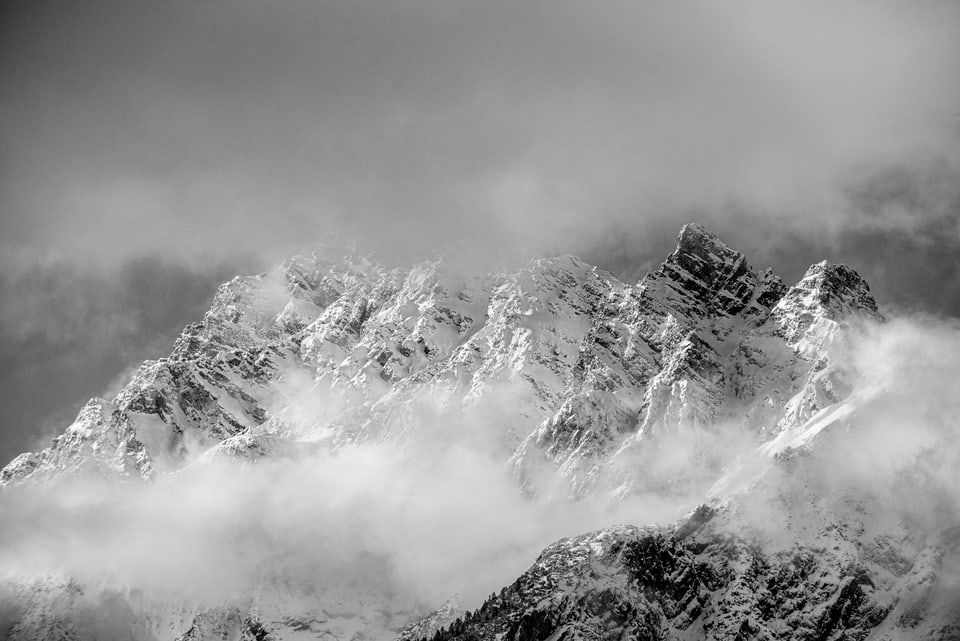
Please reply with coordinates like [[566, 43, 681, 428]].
[[732, 315, 960, 552]]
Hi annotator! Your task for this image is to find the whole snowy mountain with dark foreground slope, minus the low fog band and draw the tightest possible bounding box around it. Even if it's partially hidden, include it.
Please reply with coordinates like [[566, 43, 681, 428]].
[[0, 224, 960, 641]]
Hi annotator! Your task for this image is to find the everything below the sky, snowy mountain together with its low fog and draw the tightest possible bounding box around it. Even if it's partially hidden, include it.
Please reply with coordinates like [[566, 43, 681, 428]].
[[0, 224, 960, 641]]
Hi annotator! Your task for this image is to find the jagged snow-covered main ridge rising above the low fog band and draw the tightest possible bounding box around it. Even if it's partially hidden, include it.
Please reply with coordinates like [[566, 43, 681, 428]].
[[2, 225, 876, 495]]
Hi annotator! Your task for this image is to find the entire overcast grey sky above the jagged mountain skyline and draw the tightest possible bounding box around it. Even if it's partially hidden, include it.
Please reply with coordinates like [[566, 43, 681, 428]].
[[0, 0, 960, 461]]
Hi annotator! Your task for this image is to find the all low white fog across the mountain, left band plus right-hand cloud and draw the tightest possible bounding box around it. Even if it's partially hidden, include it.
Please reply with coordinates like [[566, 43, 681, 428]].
[[0, 316, 960, 640]]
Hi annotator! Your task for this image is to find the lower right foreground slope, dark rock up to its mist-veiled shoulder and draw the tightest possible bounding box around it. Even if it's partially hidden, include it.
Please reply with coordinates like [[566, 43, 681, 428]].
[[416, 424, 960, 641]]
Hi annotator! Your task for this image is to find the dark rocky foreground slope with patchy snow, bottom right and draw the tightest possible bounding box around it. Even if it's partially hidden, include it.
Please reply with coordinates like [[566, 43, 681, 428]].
[[408, 508, 960, 641]]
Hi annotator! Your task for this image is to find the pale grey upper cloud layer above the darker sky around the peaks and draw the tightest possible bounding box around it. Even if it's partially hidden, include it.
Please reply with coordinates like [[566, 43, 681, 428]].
[[0, 1, 960, 260]]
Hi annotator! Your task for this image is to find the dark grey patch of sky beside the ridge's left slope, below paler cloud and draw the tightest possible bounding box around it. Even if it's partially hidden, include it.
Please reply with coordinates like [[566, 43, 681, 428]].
[[0, 258, 246, 464]]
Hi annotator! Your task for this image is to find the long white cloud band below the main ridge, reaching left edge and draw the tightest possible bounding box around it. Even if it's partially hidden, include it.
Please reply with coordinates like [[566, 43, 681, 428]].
[[0, 416, 677, 611]]
